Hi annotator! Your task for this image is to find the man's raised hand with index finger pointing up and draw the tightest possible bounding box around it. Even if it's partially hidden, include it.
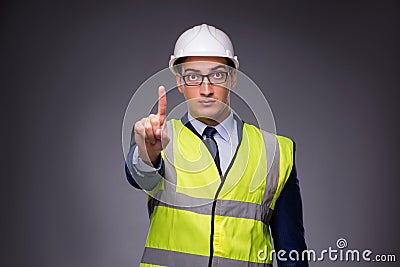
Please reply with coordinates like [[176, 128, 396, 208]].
[[135, 86, 169, 165]]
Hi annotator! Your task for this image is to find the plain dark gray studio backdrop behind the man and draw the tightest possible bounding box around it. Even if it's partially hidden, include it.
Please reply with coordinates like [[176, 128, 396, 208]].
[[0, 1, 400, 267]]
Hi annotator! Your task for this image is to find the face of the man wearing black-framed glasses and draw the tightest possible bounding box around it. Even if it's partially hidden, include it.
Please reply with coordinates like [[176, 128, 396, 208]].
[[176, 57, 236, 125]]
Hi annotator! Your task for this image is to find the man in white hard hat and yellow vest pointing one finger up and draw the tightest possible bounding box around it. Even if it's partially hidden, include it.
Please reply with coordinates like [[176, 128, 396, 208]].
[[125, 24, 308, 267]]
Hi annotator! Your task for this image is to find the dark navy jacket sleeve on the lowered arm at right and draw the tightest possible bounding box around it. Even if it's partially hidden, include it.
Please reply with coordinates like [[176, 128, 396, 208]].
[[270, 143, 308, 267]]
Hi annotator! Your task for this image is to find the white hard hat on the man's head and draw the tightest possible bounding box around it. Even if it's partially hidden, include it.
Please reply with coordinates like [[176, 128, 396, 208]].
[[169, 24, 239, 73]]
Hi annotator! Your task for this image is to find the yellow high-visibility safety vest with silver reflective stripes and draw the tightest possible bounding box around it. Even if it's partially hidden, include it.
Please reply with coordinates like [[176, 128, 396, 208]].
[[140, 120, 293, 267]]
